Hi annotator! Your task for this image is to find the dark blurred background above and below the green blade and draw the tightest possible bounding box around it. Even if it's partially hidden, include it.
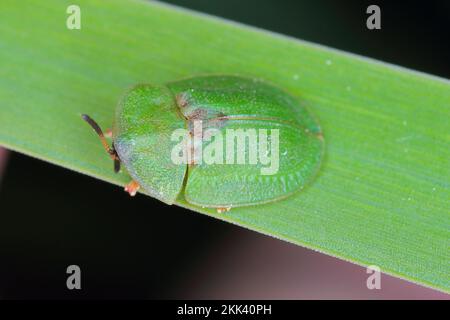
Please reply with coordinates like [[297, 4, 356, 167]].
[[0, 0, 450, 299]]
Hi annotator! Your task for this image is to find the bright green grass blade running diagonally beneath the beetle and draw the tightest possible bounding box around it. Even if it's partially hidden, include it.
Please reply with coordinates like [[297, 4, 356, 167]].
[[0, 0, 450, 292]]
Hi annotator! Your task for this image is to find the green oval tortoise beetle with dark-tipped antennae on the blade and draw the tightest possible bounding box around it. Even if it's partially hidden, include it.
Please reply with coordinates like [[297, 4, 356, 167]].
[[82, 75, 324, 212]]
